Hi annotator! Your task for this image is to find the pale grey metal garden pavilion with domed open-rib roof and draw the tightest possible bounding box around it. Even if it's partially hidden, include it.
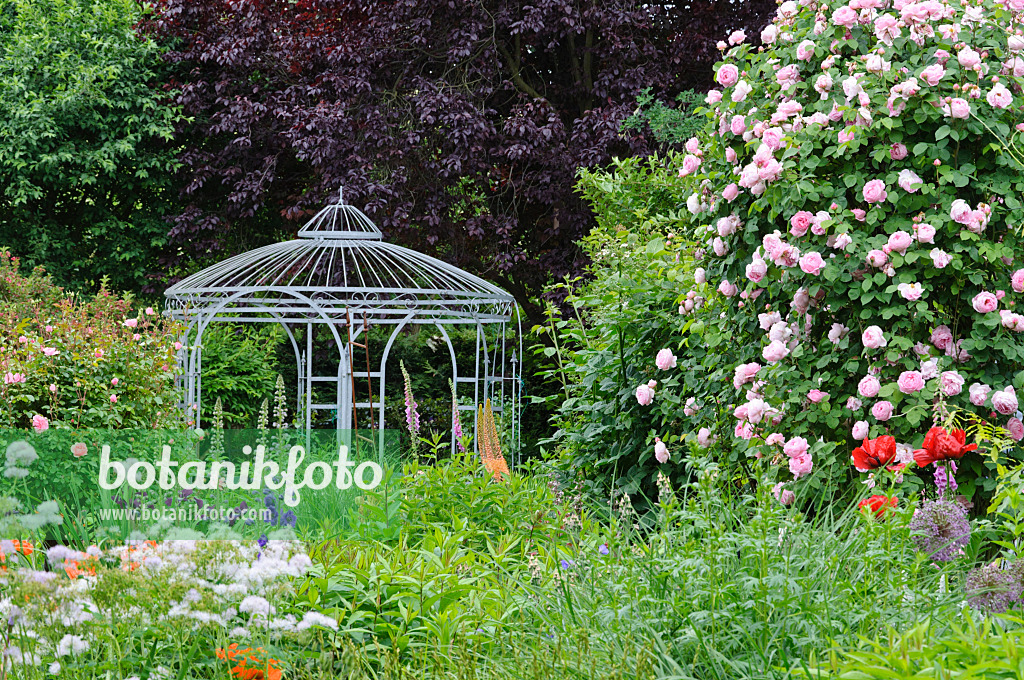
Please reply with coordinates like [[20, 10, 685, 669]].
[[164, 193, 522, 454]]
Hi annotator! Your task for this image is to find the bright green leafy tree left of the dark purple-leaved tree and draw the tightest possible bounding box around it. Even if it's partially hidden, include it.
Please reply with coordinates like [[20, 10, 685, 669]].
[[0, 0, 179, 291]]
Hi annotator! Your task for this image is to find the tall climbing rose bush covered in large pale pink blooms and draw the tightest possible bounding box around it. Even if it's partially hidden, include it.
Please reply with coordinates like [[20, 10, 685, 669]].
[[658, 0, 1024, 495]]
